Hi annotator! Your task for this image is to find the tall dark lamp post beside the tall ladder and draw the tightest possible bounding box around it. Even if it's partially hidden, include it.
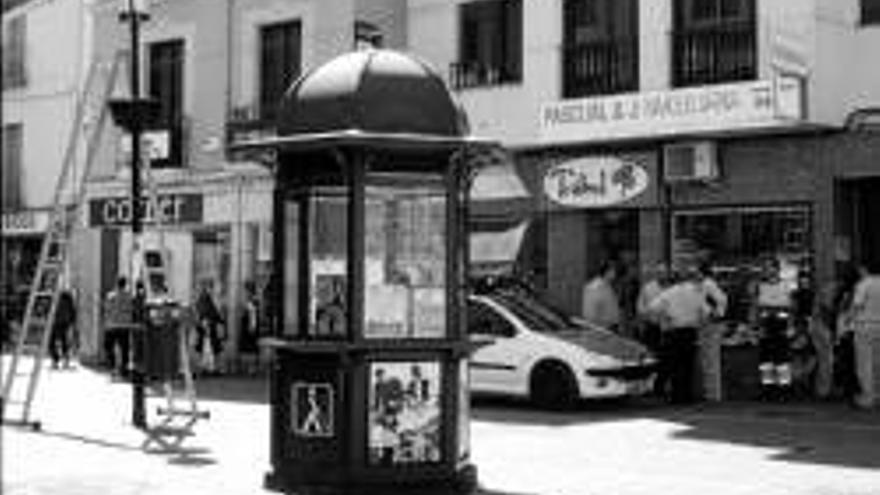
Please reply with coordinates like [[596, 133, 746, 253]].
[[109, 0, 158, 428]]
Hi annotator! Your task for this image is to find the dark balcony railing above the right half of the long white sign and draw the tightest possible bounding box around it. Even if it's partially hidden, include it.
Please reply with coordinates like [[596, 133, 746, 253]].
[[672, 22, 758, 87]]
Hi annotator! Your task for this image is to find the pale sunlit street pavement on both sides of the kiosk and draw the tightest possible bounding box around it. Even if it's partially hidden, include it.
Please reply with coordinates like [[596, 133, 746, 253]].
[[2, 360, 880, 495]]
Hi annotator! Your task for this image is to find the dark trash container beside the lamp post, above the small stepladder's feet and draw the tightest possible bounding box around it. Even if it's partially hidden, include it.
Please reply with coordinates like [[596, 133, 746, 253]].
[[144, 301, 181, 382]]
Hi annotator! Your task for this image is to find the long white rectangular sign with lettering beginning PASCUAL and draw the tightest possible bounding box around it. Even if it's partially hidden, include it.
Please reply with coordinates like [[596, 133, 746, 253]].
[[540, 76, 804, 142]]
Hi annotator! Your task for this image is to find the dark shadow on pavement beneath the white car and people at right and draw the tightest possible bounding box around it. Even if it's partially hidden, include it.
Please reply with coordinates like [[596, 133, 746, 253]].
[[471, 398, 880, 469]]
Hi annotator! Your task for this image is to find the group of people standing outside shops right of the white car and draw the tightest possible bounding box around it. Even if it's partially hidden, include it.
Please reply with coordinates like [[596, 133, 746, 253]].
[[582, 258, 880, 407]]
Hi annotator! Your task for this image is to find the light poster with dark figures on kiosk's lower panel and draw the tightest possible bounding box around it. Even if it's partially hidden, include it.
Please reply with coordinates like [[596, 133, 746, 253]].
[[368, 361, 442, 466]]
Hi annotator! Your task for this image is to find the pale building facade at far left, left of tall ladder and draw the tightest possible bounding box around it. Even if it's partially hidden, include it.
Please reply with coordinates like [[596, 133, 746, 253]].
[[0, 0, 92, 340]]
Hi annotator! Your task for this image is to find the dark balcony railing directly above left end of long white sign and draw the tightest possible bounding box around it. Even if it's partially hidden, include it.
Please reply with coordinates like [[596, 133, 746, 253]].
[[562, 37, 639, 98]]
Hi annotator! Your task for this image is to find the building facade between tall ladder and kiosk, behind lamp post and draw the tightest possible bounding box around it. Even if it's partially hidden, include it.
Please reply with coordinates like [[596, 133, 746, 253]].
[[82, 0, 406, 364]]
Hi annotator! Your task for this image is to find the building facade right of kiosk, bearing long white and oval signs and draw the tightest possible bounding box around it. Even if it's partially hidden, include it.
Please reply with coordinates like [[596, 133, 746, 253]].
[[407, 0, 880, 326]]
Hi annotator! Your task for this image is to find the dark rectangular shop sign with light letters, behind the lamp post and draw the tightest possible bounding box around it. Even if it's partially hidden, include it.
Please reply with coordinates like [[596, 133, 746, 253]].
[[89, 194, 203, 227]]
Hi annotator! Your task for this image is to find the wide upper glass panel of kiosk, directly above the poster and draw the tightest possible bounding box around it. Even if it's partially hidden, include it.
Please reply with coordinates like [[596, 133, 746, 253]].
[[364, 174, 447, 338]]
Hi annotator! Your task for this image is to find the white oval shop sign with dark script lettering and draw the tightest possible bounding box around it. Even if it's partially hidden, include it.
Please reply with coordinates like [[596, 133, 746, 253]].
[[544, 156, 650, 208]]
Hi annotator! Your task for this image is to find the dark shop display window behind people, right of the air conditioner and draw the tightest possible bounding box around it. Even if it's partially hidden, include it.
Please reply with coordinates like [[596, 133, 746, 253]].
[[673, 206, 812, 321]]
